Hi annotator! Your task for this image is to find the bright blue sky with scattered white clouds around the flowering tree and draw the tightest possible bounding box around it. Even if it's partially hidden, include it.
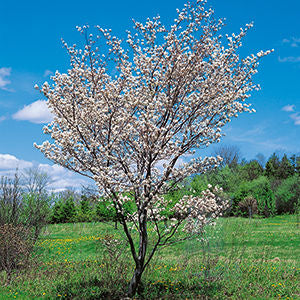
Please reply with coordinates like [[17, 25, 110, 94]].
[[0, 0, 300, 188]]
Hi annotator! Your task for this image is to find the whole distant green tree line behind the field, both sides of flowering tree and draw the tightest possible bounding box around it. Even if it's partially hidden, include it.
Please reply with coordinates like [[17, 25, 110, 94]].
[[42, 146, 300, 223]]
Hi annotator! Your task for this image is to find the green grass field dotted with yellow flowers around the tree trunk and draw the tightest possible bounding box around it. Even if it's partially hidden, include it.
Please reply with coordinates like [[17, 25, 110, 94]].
[[0, 216, 300, 299]]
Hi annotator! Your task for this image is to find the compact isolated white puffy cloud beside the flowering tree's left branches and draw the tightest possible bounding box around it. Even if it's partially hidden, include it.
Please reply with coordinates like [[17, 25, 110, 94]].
[[13, 100, 53, 124]]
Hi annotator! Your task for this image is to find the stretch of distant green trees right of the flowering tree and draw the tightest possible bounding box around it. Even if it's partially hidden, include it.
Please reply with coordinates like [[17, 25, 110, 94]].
[[178, 146, 300, 217]]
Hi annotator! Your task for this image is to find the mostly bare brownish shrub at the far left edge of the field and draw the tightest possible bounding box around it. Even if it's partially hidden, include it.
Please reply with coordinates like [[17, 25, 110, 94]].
[[0, 173, 49, 280]]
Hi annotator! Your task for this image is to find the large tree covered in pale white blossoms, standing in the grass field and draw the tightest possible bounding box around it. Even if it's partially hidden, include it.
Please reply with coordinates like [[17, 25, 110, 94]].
[[35, 0, 270, 296]]
